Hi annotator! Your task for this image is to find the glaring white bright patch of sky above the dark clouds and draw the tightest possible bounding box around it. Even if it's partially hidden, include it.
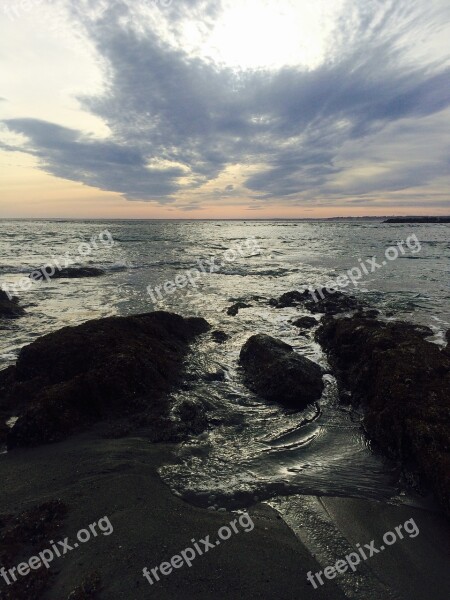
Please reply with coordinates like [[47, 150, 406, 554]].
[[181, 0, 343, 69]]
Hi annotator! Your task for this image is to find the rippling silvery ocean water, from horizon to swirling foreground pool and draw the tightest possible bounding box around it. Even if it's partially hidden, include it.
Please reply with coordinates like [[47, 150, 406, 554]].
[[0, 219, 450, 528]]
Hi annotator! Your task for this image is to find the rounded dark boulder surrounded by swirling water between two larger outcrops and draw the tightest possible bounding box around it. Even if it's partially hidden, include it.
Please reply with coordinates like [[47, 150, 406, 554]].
[[240, 334, 324, 408]]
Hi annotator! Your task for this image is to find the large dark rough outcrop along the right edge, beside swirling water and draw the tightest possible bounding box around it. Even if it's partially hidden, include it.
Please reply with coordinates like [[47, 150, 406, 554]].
[[316, 315, 450, 516]]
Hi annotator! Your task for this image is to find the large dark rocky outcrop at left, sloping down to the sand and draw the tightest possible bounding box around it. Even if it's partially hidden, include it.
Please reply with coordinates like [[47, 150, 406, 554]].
[[0, 312, 209, 448]]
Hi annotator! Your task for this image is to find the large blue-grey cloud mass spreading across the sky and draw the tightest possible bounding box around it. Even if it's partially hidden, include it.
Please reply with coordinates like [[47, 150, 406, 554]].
[[6, 0, 450, 204]]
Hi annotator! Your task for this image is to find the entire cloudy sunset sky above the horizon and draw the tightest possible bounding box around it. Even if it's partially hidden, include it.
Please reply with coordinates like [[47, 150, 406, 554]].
[[0, 0, 450, 219]]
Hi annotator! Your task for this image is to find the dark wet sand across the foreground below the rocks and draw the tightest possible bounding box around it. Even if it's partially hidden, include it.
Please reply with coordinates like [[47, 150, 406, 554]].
[[0, 431, 450, 600]]
